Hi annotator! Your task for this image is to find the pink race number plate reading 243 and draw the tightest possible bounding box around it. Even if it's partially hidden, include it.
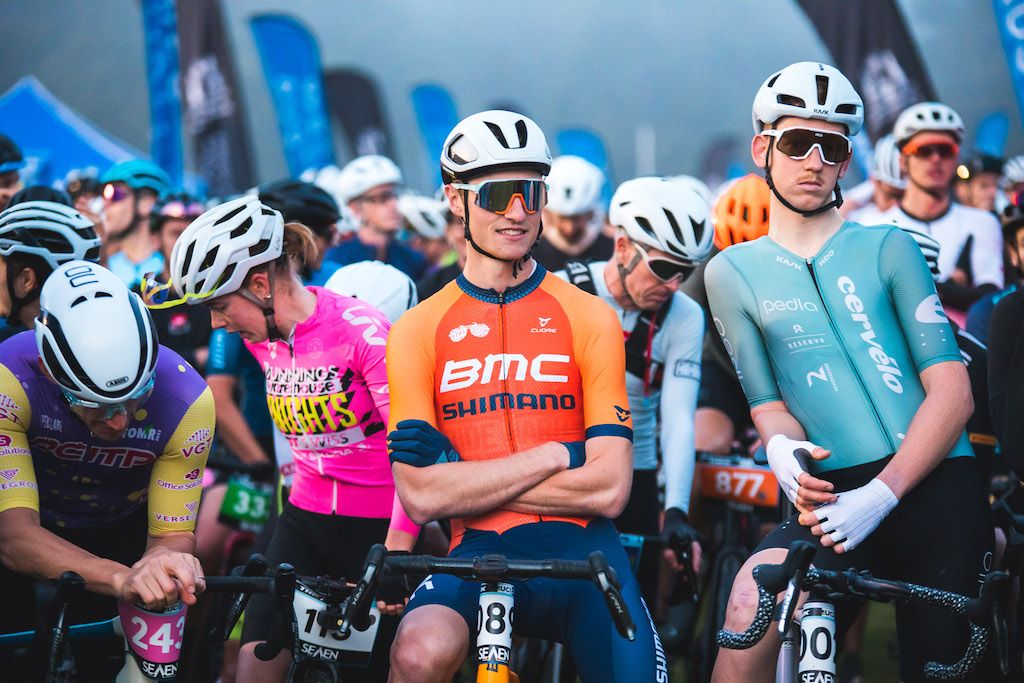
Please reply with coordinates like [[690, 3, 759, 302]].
[[118, 600, 186, 681]]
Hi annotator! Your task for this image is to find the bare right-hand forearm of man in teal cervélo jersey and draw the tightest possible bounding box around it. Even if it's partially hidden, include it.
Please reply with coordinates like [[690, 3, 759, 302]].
[[879, 370, 973, 499]]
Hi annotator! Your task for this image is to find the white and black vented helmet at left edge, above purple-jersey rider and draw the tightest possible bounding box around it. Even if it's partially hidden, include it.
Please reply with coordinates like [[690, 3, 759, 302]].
[[0, 201, 99, 270]]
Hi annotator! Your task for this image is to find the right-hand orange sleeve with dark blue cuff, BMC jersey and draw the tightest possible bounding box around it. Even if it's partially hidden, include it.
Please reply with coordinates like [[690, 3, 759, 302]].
[[572, 295, 633, 440]]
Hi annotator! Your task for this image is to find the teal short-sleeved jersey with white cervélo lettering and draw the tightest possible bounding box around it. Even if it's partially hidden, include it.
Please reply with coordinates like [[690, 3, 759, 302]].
[[705, 222, 973, 472]]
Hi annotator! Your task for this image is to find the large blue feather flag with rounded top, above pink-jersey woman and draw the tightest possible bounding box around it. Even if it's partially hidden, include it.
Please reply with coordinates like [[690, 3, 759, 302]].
[[250, 14, 334, 176]]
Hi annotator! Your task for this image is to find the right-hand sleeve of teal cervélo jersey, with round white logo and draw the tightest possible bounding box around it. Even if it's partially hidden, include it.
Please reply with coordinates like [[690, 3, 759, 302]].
[[879, 229, 963, 373]]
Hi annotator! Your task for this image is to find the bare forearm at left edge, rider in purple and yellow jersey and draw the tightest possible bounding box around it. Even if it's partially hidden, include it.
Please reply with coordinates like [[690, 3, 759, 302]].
[[0, 508, 128, 595]]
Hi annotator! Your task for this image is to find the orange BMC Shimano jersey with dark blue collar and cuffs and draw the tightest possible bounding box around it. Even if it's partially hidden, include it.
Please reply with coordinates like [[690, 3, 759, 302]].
[[387, 264, 633, 547]]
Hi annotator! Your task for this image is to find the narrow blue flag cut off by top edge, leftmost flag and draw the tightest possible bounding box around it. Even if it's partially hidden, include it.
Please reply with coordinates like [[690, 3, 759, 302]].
[[142, 0, 184, 185]]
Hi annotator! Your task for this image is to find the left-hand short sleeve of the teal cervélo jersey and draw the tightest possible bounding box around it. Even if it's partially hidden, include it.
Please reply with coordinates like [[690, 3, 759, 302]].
[[705, 252, 782, 408]]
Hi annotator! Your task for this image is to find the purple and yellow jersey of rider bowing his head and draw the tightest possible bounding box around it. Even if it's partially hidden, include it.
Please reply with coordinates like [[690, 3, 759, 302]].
[[0, 331, 214, 536]]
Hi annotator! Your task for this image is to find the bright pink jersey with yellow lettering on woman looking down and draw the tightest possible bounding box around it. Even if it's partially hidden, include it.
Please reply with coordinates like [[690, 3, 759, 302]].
[[246, 287, 408, 526]]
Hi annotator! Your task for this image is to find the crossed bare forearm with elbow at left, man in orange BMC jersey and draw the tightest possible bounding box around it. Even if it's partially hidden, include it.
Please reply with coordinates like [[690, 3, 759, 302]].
[[391, 442, 568, 524]]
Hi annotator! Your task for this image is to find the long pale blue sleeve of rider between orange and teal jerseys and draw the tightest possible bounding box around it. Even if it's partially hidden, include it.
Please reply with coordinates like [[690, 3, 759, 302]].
[[658, 298, 705, 512]]
